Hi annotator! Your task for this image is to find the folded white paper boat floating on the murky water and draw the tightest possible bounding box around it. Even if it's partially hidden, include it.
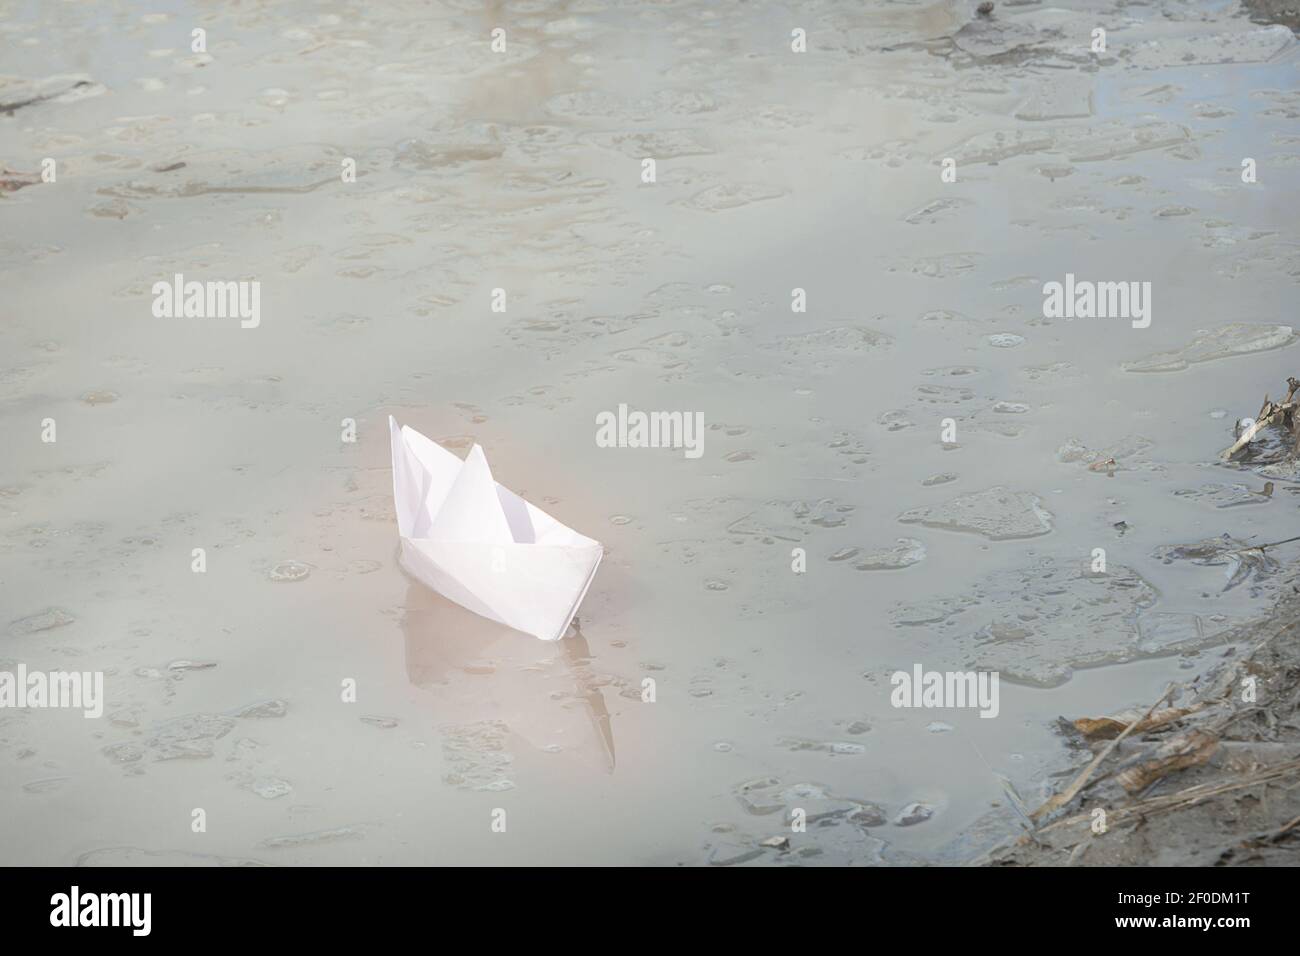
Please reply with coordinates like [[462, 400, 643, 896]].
[[389, 415, 605, 641]]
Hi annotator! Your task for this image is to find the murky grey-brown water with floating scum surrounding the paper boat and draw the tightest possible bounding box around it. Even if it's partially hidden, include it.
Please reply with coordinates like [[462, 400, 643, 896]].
[[0, 1, 1300, 864]]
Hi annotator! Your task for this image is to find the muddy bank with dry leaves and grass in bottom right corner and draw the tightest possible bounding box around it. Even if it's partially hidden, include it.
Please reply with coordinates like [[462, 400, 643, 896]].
[[980, 564, 1300, 866]]
